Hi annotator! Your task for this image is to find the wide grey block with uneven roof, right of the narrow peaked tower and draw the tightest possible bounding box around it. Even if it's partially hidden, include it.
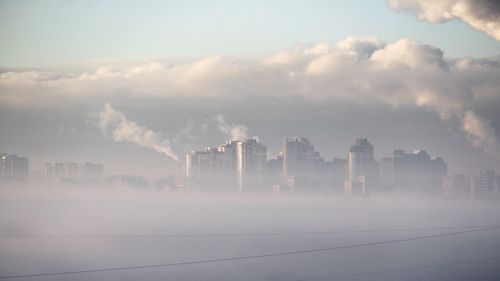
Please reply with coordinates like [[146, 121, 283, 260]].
[[380, 150, 448, 192]]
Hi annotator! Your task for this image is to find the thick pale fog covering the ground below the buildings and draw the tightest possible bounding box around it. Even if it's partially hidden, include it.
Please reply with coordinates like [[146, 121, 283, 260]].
[[0, 186, 500, 281]]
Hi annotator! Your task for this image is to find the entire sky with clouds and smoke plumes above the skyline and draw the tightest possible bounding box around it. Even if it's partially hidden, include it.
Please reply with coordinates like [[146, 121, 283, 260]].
[[0, 0, 500, 177]]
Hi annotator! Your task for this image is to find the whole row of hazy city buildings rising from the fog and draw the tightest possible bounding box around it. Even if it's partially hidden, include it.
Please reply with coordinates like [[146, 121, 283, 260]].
[[0, 133, 500, 199]]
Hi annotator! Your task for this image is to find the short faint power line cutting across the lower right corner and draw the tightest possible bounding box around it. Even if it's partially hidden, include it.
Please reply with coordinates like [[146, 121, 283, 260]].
[[294, 256, 500, 281]]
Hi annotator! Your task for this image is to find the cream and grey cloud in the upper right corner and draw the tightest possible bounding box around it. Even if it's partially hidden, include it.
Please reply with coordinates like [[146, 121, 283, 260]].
[[387, 0, 500, 40]]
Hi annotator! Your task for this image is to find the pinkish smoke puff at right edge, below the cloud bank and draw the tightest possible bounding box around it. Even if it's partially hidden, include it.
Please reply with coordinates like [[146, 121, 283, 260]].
[[462, 110, 500, 159]]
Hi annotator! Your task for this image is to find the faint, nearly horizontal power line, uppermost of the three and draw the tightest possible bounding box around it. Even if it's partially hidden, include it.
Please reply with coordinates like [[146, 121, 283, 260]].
[[0, 225, 497, 239]]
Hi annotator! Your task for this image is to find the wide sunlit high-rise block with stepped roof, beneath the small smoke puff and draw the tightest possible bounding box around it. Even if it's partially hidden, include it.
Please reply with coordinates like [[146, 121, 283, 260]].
[[186, 138, 267, 191]]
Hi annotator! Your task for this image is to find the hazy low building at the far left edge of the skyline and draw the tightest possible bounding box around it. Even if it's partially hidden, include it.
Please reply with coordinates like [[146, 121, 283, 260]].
[[0, 152, 29, 181]]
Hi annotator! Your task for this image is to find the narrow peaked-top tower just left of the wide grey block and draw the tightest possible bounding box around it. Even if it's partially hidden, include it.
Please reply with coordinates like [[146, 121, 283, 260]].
[[344, 138, 379, 194]]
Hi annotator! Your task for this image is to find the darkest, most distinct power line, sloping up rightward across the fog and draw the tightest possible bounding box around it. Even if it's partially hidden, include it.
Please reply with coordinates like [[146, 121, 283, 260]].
[[0, 226, 500, 279]]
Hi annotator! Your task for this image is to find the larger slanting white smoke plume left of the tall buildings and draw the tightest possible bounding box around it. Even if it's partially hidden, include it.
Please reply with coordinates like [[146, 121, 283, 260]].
[[99, 103, 179, 161]]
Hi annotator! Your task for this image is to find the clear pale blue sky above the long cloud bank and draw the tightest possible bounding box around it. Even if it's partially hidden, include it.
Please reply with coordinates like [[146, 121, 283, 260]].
[[0, 0, 500, 67]]
